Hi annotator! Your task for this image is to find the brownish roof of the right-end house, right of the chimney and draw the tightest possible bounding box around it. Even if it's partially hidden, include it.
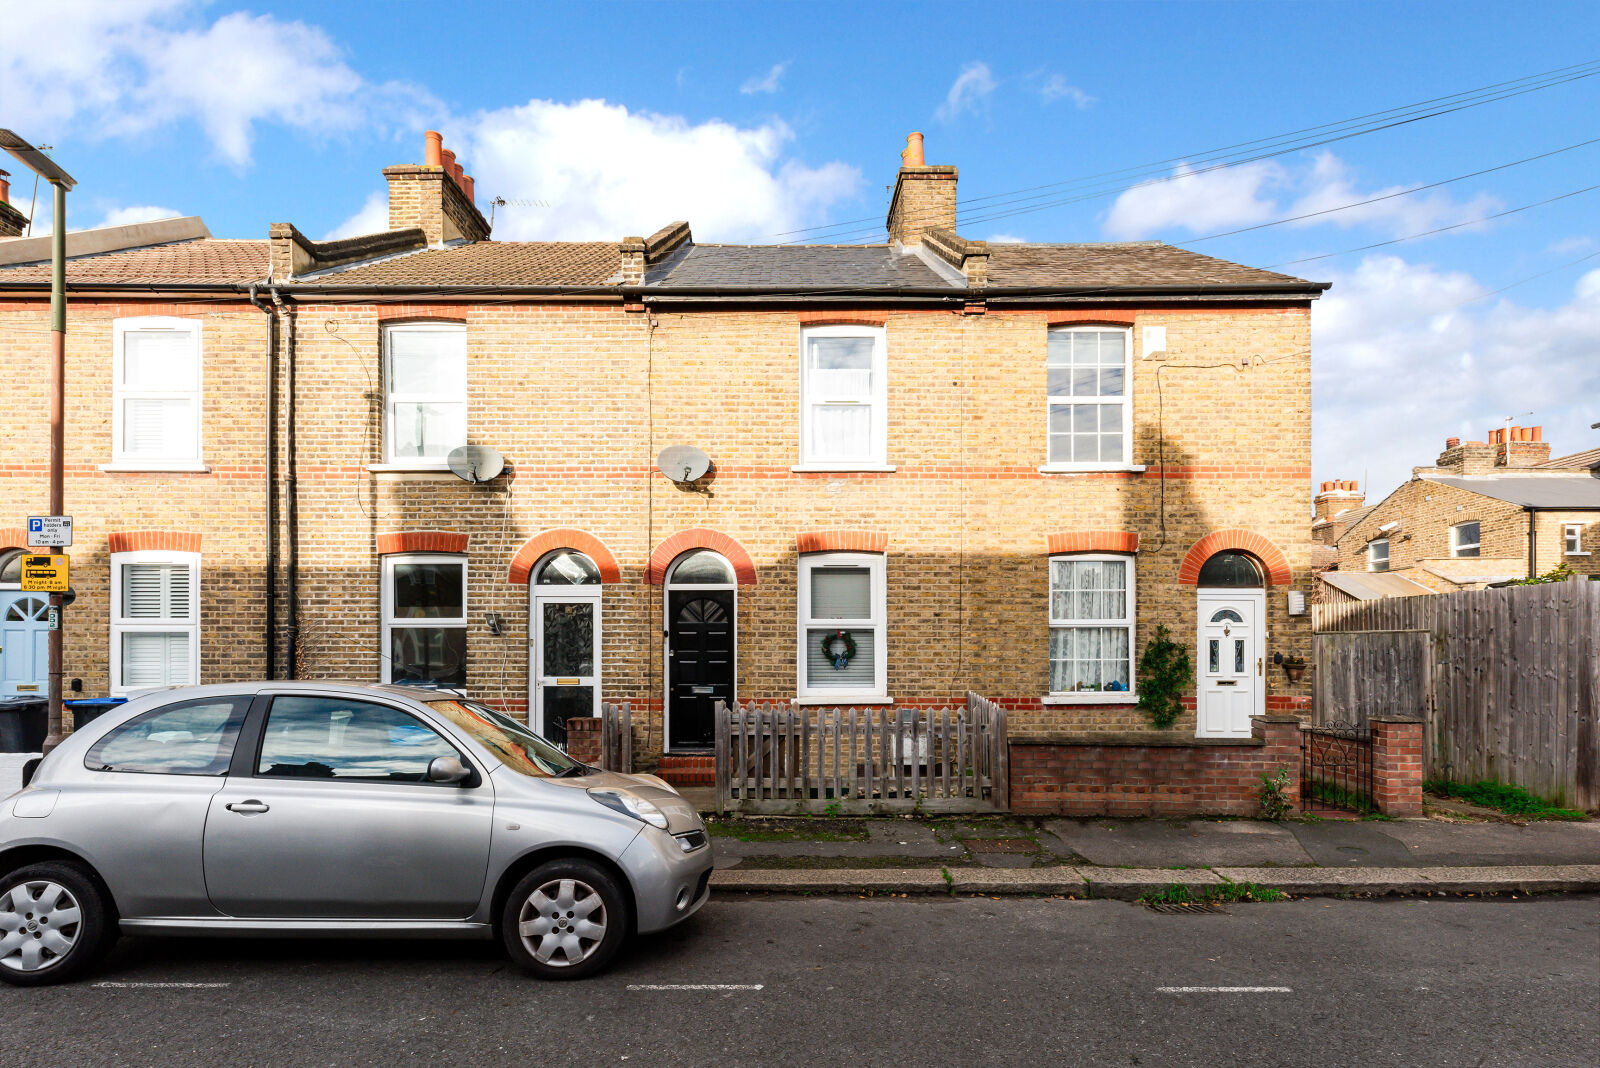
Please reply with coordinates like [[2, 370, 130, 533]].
[[989, 241, 1326, 289]]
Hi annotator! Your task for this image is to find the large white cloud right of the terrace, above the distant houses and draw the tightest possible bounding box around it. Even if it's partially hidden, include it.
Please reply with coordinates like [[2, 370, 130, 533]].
[[1312, 256, 1600, 500]]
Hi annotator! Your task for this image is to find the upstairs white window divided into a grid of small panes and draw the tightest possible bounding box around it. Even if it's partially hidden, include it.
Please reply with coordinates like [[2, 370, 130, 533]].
[[1045, 326, 1133, 467]]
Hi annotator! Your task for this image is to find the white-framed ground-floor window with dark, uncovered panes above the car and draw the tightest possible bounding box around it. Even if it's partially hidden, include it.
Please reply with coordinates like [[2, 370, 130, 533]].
[[381, 555, 467, 686]]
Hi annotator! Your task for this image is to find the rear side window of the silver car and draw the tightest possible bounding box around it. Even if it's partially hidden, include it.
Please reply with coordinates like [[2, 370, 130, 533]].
[[83, 697, 250, 775]]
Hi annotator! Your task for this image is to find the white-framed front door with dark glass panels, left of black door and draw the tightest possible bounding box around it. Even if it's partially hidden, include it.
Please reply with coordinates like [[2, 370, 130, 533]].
[[533, 596, 600, 745]]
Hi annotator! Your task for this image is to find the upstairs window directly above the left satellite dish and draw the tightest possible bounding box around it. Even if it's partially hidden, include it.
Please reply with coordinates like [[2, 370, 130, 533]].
[[384, 323, 467, 465]]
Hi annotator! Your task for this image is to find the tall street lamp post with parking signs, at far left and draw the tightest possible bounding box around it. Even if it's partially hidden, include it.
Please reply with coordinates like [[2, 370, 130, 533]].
[[0, 130, 77, 753]]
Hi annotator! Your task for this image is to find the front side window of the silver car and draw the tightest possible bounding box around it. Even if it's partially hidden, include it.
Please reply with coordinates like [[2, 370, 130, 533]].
[[256, 697, 461, 782]]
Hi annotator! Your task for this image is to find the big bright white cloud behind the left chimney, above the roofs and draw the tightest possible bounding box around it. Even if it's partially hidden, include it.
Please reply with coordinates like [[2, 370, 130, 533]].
[[321, 101, 861, 241]]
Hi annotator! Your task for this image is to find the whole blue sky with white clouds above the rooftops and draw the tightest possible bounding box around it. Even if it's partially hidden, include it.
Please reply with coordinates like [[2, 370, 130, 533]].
[[0, 0, 1600, 494]]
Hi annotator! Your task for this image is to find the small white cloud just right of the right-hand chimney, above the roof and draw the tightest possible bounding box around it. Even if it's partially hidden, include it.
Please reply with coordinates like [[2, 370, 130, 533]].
[[1104, 160, 1283, 240]]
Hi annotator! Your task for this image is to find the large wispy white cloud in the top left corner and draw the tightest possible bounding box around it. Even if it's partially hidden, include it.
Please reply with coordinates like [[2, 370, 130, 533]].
[[0, 0, 437, 166]]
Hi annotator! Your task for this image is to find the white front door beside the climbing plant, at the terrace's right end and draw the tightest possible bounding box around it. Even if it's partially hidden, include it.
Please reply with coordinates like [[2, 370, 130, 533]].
[[1195, 590, 1266, 737]]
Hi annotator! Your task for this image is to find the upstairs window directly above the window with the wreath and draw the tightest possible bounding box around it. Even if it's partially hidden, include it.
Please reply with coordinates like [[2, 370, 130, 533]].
[[800, 326, 888, 468]]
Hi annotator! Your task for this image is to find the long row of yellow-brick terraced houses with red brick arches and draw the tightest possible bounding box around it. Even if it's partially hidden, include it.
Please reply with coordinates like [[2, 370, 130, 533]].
[[0, 136, 1325, 764]]
